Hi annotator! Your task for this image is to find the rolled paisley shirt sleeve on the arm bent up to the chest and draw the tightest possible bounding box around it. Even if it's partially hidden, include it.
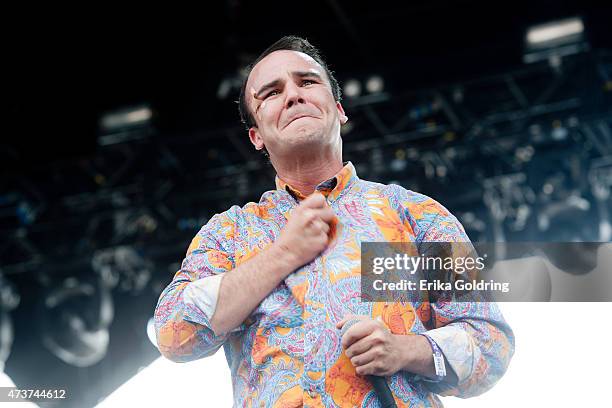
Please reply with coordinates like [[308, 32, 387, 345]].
[[155, 214, 245, 362]]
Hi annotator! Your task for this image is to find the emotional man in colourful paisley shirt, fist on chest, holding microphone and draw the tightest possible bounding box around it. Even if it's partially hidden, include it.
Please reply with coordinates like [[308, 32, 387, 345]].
[[155, 37, 514, 407]]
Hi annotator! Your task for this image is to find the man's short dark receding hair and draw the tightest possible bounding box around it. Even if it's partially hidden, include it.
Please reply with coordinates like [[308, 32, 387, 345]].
[[238, 35, 342, 129]]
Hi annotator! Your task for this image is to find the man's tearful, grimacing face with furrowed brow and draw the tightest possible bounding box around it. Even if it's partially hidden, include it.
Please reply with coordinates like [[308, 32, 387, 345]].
[[245, 50, 347, 159]]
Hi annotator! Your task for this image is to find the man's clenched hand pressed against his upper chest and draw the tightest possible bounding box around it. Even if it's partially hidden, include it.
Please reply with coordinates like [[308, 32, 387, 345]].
[[275, 192, 335, 272]]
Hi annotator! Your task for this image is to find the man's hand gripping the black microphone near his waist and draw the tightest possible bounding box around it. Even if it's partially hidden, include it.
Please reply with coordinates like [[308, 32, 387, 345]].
[[336, 315, 407, 377]]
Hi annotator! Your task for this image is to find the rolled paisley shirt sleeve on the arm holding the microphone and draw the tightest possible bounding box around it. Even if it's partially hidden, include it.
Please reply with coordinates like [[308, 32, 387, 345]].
[[412, 199, 514, 398]]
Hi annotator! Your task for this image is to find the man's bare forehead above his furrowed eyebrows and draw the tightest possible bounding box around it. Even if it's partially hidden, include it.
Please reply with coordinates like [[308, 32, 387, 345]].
[[247, 50, 327, 89]]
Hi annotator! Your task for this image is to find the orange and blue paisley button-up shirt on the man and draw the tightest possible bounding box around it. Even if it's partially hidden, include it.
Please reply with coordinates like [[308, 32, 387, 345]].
[[155, 162, 514, 408]]
